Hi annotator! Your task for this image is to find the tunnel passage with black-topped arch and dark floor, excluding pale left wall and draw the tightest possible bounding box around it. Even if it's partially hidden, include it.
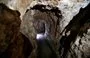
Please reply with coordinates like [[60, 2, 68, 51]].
[[31, 4, 62, 58]]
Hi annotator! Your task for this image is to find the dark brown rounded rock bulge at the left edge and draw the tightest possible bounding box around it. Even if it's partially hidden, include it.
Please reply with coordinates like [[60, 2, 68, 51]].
[[0, 4, 21, 51]]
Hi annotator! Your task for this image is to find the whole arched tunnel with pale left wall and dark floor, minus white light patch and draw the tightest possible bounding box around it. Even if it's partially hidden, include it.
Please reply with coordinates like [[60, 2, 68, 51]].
[[21, 4, 62, 58]]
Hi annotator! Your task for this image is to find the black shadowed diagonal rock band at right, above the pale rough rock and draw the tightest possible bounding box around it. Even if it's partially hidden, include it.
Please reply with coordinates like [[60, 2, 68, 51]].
[[59, 3, 90, 58]]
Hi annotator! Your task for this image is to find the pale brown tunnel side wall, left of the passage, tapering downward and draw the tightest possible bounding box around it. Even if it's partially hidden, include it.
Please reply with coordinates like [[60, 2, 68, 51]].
[[20, 5, 37, 58]]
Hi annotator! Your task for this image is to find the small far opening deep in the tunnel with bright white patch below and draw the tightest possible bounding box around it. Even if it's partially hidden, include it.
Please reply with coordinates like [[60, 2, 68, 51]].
[[34, 20, 46, 40]]
